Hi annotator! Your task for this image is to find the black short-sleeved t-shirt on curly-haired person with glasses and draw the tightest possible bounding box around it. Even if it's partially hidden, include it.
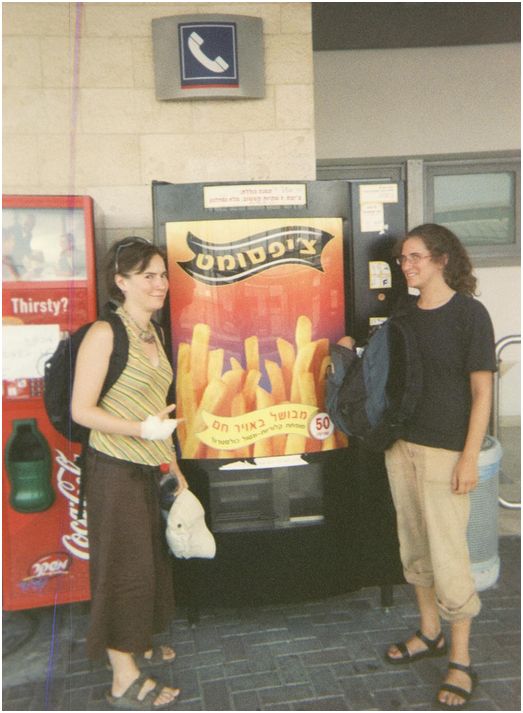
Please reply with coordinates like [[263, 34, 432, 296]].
[[404, 293, 496, 451]]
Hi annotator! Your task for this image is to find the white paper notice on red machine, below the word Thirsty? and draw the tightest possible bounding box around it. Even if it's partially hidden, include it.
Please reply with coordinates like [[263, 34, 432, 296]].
[[2, 324, 60, 381]]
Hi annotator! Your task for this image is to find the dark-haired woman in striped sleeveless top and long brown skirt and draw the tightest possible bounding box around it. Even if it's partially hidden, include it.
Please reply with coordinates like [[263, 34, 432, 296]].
[[72, 237, 187, 710]]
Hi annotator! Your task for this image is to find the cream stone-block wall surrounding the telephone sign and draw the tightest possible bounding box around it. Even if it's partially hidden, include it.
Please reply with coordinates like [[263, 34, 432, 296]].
[[2, 3, 316, 252]]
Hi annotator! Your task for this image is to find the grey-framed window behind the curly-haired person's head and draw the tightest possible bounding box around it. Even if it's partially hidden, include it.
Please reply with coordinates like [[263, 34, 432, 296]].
[[317, 151, 521, 266]]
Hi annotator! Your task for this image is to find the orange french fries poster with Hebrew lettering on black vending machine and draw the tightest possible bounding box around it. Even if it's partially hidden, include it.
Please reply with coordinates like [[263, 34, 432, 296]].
[[166, 218, 347, 459]]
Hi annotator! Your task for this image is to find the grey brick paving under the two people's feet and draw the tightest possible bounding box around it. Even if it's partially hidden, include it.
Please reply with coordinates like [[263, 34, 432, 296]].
[[3, 537, 521, 711]]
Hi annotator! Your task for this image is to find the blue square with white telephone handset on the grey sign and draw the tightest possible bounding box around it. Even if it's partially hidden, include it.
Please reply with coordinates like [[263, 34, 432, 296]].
[[178, 22, 239, 89]]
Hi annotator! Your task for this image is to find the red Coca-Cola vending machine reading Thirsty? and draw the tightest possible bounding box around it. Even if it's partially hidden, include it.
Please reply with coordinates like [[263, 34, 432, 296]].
[[2, 196, 97, 610]]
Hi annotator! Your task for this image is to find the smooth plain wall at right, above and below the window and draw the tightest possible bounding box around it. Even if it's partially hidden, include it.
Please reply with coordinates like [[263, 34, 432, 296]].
[[314, 44, 521, 417]]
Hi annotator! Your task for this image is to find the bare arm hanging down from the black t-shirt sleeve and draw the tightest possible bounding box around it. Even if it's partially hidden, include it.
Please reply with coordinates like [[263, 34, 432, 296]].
[[452, 371, 492, 495]]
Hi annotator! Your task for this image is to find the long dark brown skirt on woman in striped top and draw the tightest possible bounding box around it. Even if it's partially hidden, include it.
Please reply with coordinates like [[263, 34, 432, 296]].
[[84, 448, 174, 659]]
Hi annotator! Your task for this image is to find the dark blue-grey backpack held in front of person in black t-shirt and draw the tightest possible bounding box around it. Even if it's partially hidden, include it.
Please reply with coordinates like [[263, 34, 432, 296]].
[[325, 316, 422, 451]]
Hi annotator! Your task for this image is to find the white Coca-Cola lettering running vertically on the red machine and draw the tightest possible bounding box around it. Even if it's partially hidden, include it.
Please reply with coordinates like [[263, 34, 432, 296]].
[[55, 448, 89, 560]]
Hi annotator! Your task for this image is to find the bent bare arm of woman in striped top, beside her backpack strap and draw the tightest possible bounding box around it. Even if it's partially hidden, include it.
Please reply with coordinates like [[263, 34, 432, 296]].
[[71, 322, 141, 436]]
